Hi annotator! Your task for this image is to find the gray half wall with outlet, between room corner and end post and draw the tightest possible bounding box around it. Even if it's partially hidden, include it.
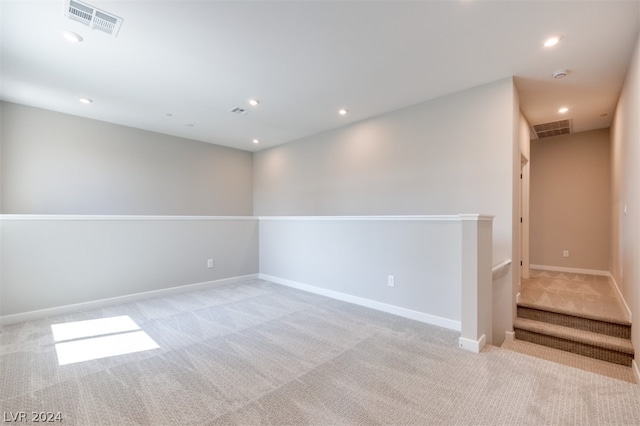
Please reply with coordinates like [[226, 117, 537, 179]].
[[260, 217, 462, 331]]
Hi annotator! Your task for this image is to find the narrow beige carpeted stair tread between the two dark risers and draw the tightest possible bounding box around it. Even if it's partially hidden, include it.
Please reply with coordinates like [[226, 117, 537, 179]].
[[513, 317, 634, 355]]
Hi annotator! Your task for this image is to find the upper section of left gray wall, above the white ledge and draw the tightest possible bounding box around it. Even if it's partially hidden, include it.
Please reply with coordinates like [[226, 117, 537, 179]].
[[0, 102, 253, 216]]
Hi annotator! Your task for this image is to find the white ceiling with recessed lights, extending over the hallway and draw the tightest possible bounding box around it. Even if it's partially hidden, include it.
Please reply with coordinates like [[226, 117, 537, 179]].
[[0, 0, 640, 151]]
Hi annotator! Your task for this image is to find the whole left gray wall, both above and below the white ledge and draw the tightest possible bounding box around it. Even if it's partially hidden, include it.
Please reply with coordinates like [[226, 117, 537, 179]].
[[0, 102, 258, 320]]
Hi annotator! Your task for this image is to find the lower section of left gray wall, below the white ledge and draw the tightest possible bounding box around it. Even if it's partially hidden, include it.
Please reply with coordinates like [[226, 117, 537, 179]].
[[0, 216, 258, 317]]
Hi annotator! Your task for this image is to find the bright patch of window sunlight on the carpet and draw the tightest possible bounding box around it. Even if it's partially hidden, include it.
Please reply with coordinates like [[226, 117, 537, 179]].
[[51, 315, 160, 365]]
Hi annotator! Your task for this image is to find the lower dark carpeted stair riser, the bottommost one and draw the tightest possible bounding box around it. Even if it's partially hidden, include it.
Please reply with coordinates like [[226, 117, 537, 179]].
[[514, 328, 633, 367]]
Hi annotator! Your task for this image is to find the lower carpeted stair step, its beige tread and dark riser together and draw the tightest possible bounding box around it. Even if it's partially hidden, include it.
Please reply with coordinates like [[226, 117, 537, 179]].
[[513, 318, 633, 367]]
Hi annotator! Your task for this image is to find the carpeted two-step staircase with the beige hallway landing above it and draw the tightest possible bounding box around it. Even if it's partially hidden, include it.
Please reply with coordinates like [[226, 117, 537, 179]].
[[512, 270, 634, 380]]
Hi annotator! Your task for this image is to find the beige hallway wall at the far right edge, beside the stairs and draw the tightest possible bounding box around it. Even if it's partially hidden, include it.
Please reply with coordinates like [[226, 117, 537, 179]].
[[611, 30, 640, 368]]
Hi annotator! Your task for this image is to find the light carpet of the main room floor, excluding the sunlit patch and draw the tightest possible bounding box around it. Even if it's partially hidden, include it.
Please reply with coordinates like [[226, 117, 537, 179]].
[[0, 280, 640, 425]]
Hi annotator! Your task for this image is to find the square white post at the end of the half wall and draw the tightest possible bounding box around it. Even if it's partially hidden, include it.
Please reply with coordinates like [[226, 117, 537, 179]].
[[458, 214, 493, 353]]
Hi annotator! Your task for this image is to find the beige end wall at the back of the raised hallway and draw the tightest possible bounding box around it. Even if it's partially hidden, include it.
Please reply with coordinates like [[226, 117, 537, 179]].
[[530, 129, 611, 271]]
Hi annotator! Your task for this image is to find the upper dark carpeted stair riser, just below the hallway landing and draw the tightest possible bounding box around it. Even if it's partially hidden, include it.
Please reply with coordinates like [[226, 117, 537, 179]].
[[518, 306, 631, 339]]
